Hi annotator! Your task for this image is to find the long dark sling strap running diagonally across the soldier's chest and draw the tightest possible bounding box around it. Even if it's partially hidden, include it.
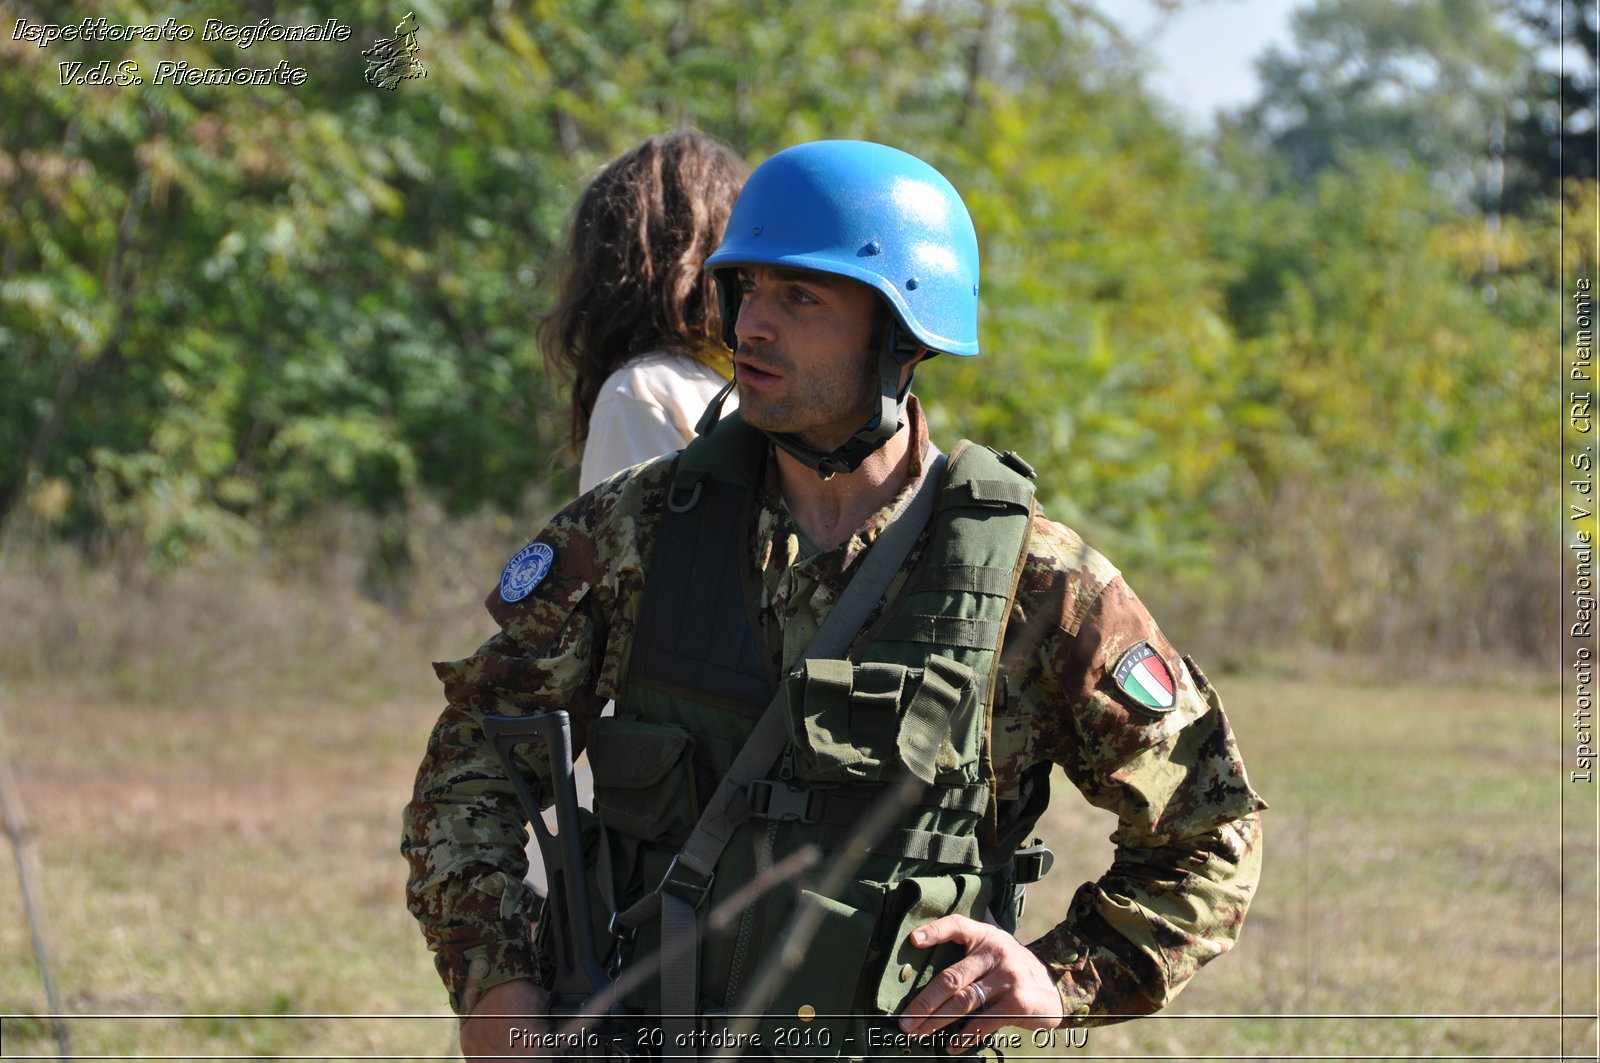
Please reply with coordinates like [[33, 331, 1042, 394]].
[[616, 443, 946, 1044]]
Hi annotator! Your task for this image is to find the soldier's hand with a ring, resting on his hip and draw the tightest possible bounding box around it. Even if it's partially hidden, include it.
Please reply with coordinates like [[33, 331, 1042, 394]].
[[899, 916, 1061, 1053]]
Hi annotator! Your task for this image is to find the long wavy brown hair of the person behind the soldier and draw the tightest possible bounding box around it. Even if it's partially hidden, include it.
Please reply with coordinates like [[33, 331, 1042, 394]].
[[539, 131, 749, 453]]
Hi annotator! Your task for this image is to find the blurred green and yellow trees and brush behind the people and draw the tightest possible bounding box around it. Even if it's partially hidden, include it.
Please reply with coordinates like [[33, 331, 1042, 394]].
[[0, 0, 1574, 665]]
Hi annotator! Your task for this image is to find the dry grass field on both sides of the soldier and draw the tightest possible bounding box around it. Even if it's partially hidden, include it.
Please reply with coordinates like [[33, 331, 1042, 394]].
[[0, 676, 1597, 1060]]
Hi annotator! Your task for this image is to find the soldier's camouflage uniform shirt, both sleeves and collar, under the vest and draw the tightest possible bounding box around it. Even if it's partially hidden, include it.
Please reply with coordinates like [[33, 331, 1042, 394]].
[[402, 400, 1266, 1025]]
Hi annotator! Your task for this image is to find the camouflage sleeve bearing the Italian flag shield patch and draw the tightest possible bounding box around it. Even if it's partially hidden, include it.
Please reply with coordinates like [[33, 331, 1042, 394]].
[[997, 520, 1266, 1026]]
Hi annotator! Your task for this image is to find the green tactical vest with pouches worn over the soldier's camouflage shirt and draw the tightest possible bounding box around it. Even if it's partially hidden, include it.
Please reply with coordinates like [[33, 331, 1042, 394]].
[[563, 415, 1037, 1057]]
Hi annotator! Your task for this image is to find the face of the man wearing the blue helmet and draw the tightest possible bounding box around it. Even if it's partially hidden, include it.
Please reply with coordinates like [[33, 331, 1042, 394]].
[[733, 266, 878, 450]]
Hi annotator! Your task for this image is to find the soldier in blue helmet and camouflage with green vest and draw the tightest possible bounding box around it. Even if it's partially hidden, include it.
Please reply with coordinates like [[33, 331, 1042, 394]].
[[403, 141, 1264, 1058]]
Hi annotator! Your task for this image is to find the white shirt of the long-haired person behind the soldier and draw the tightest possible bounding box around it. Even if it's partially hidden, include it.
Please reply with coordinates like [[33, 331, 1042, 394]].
[[578, 351, 738, 491]]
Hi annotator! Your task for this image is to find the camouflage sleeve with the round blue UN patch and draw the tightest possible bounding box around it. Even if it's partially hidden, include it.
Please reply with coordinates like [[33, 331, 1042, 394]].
[[402, 466, 672, 1015]]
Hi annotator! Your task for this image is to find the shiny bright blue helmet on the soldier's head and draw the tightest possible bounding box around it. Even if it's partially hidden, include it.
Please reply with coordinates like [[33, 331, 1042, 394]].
[[706, 141, 978, 355]]
